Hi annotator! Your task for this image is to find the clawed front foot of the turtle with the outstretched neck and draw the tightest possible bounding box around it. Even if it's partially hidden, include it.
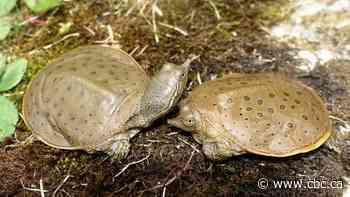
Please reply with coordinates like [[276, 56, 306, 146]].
[[108, 129, 139, 160]]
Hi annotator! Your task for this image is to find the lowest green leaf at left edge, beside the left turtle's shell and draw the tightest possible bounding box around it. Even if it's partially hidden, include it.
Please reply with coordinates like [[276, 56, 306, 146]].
[[0, 96, 18, 141]]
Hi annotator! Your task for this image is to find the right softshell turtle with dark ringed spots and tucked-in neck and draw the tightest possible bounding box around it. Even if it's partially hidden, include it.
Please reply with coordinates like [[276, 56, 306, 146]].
[[168, 74, 331, 160]]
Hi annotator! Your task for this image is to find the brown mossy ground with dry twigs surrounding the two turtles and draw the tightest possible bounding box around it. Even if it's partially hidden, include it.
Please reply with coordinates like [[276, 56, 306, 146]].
[[0, 0, 350, 196]]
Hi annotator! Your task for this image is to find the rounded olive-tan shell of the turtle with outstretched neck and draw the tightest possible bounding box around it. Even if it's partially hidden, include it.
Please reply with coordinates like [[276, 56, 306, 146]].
[[23, 46, 149, 150]]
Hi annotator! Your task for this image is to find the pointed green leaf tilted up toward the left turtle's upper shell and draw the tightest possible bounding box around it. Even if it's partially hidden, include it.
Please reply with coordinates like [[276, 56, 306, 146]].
[[0, 58, 27, 92]]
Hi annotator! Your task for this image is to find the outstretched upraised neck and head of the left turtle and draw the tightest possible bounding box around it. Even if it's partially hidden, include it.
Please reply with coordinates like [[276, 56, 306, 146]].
[[130, 57, 197, 127]]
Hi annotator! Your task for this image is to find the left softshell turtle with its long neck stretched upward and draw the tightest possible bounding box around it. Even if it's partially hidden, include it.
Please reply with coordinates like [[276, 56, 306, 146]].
[[23, 46, 194, 159]]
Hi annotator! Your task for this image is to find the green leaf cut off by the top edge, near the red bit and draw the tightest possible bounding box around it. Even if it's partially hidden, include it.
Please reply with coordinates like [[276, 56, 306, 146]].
[[24, 0, 62, 13]]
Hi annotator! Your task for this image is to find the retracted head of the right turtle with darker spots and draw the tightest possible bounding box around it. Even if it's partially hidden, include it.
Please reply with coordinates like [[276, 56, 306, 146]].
[[168, 101, 201, 133]]
